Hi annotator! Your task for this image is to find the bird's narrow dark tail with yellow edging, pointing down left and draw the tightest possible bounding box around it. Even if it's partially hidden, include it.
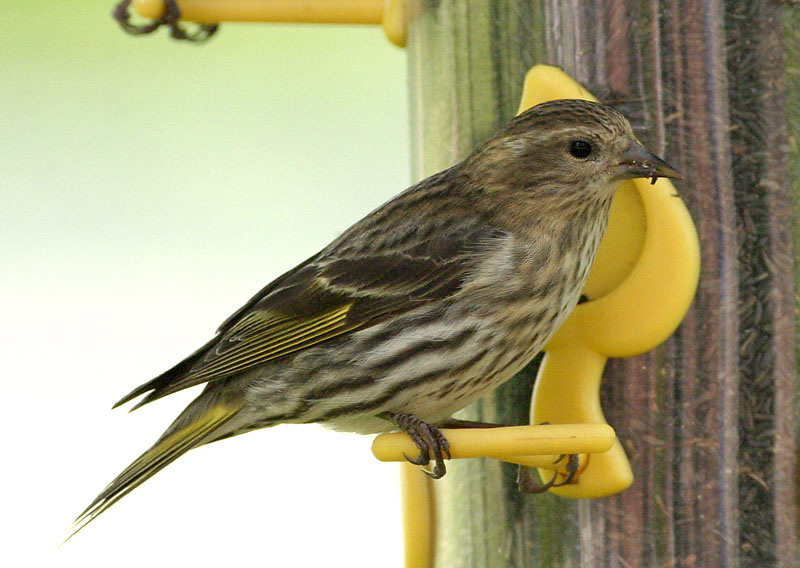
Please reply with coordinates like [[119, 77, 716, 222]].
[[64, 393, 241, 542]]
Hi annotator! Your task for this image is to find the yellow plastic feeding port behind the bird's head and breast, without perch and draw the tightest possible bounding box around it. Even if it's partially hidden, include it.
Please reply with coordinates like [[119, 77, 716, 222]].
[[520, 65, 700, 498]]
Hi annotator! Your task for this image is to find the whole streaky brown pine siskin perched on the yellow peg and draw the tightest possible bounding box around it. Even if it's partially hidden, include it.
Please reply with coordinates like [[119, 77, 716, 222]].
[[73, 100, 678, 534]]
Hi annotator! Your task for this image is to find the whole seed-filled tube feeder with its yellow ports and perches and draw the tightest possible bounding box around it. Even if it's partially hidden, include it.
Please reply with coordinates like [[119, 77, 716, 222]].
[[112, 0, 800, 568]]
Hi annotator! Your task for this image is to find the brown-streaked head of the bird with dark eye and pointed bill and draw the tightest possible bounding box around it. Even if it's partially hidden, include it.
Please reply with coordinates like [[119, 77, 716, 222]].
[[467, 99, 680, 212]]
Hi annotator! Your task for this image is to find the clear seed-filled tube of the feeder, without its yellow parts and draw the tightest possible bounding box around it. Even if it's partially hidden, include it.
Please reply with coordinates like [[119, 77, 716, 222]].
[[408, 0, 800, 568]]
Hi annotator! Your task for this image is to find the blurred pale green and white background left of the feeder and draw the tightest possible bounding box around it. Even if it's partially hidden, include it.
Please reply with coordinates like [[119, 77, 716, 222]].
[[0, 0, 410, 567]]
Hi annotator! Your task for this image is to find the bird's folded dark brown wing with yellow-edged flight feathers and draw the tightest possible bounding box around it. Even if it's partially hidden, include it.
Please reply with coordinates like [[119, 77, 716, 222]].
[[115, 217, 500, 408]]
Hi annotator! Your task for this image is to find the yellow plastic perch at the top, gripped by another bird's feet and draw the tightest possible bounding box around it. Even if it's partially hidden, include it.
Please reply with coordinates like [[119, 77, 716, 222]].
[[133, 0, 407, 47]]
